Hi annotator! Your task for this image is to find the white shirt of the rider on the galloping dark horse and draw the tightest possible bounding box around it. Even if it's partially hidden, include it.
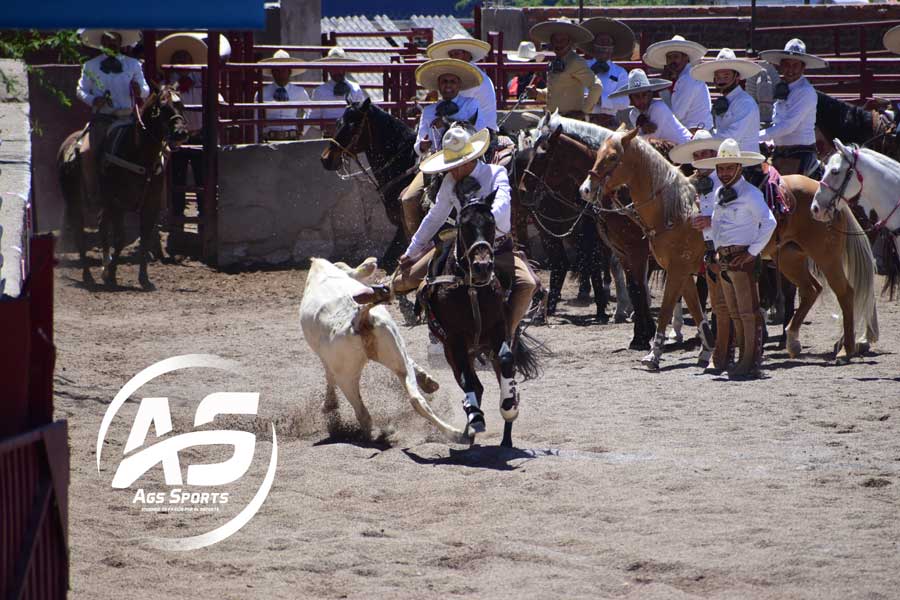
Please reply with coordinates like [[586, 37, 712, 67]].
[[405, 161, 511, 259]]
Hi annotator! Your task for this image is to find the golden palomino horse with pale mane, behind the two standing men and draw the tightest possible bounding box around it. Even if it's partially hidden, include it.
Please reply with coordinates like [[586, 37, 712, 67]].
[[581, 129, 878, 361]]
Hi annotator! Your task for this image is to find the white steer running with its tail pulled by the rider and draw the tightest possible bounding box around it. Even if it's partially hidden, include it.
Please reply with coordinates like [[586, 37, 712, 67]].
[[300, 258, 467, 442]]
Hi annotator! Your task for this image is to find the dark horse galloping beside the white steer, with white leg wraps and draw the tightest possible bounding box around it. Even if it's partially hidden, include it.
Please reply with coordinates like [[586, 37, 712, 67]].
[[419, 190, 540, 447]]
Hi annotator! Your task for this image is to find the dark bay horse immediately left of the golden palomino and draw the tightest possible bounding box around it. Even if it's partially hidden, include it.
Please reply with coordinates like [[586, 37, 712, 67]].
[[519, 117, 656, 350]]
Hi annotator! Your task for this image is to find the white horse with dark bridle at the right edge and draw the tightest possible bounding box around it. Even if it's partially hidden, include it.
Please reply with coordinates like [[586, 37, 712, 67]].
[[812, 138, 900, 298]]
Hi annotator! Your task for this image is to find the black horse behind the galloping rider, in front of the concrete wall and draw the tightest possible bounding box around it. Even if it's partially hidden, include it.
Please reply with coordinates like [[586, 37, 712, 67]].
[[321, 98, 418, 270]]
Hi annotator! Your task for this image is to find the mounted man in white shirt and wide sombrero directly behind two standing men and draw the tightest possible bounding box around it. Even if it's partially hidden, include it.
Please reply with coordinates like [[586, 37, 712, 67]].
[[691, 48, 765, 187]]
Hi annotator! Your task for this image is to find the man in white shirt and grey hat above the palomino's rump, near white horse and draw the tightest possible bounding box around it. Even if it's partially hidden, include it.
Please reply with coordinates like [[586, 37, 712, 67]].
[[759, 39, 828, 179]]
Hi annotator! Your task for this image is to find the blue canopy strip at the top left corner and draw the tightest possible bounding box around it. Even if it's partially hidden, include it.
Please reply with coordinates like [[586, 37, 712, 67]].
[[0, 0, 266, 30]]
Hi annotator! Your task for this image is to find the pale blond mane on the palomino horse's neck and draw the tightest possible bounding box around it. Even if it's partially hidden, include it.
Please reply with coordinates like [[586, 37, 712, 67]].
[[616, 132, 697, 224]]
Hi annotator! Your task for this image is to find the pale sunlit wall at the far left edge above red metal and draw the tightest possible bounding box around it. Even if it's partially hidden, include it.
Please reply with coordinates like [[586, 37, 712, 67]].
[[0, 60, 32, 298]]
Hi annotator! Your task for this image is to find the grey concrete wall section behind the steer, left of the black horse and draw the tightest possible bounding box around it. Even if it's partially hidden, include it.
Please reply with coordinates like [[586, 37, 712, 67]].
[[218, 140, 396, 267]]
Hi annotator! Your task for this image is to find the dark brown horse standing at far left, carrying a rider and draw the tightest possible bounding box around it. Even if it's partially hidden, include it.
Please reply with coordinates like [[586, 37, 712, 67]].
[[57, 86, 188, 290]]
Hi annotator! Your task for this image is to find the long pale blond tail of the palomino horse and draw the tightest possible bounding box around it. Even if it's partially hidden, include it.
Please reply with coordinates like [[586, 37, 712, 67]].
[[841, 206, 878, 343]]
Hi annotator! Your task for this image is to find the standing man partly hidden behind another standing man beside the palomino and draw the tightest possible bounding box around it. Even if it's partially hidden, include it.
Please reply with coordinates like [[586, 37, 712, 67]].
[[669, 129, 731, 375]]
